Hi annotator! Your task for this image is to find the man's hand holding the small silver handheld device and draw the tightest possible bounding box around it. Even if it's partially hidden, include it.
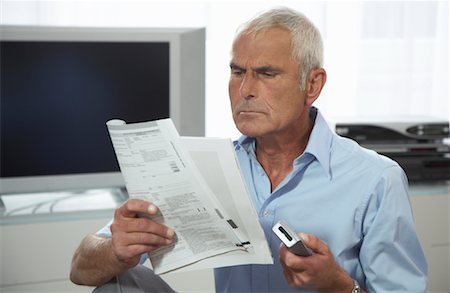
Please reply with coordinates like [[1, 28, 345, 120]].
[[280, 233, 353, 292]]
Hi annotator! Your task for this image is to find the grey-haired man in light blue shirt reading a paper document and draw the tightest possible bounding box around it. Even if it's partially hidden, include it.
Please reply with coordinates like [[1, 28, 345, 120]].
[[71, 8, 427, 293]]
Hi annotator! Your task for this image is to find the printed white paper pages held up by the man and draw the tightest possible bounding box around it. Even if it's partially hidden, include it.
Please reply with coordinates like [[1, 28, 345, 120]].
[[107, 119, 273, 274]]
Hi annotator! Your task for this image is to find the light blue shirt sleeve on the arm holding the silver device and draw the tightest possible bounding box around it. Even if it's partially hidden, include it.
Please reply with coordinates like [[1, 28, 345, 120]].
[[360, 166, 427, 292]]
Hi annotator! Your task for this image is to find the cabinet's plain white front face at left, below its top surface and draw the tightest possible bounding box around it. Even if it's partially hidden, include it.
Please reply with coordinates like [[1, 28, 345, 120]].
[[0, 218, 103, 293]]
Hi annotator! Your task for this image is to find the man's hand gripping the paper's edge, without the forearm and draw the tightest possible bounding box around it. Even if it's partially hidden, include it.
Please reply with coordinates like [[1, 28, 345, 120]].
[[111, 199, 175, 268]]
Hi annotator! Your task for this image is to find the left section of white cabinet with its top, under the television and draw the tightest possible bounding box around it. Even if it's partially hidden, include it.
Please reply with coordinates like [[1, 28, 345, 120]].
[[0, 189, 125, 292]]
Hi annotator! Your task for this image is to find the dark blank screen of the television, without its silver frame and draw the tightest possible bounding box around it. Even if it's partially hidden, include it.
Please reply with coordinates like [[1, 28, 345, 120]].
[[0, 41, 170, 177]]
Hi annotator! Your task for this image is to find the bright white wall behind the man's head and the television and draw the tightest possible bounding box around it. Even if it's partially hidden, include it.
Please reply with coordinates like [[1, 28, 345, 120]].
[[0, 0, 450, 138]]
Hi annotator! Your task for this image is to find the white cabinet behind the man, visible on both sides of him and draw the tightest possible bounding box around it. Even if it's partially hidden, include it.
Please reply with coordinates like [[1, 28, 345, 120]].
[[0, 184, 450, 293]]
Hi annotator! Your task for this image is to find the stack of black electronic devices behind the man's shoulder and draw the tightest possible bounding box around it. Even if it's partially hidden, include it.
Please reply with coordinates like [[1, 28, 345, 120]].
[[335, 117, 450, 182]]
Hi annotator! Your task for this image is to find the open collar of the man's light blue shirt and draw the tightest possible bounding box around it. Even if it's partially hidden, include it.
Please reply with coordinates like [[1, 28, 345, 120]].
[[235, 107, 333, 179]]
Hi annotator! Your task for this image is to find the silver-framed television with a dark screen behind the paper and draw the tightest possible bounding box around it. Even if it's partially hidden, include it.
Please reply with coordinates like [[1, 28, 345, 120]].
[[0, 26, 205, 194]]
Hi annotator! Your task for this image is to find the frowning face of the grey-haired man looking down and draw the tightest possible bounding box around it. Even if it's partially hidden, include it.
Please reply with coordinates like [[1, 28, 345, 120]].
[[229, 28, 308, 137]]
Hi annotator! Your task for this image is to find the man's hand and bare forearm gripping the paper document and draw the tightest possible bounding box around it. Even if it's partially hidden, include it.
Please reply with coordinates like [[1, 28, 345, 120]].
[[70, 199, 175, 286]]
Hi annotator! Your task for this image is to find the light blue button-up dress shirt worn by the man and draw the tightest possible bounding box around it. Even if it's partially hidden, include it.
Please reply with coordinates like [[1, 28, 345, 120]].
[[214, 108, 427, 292]]
